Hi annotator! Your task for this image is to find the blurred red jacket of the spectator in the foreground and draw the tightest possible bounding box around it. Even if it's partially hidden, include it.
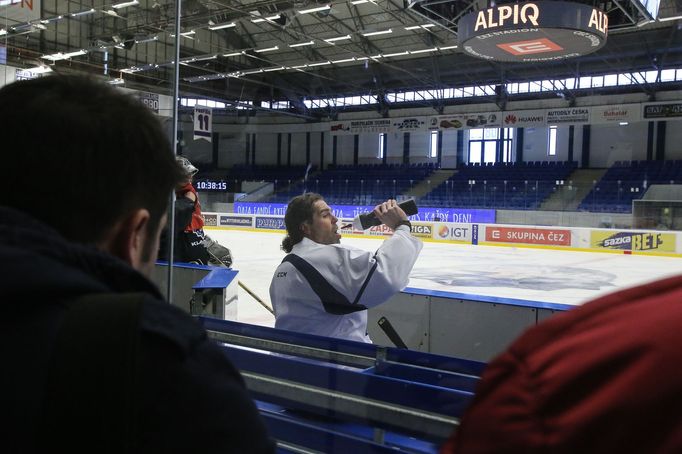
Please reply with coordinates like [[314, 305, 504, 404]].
[[441, 277, 682, 454]]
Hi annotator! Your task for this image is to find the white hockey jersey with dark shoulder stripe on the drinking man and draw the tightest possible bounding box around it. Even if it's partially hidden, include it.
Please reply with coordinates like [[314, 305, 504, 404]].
[[270, 225, 423, 342]]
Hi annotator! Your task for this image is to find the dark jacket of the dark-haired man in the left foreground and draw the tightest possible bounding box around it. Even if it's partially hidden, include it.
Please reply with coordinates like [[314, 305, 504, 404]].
[[0, 207, 275, 453]]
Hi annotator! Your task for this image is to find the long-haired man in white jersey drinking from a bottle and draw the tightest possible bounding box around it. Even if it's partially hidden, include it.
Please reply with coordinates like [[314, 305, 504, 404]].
[[270, 193, 423, 342]]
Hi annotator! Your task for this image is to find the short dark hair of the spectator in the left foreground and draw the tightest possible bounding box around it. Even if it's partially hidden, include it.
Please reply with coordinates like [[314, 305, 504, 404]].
[[0, 76, 183, 258]]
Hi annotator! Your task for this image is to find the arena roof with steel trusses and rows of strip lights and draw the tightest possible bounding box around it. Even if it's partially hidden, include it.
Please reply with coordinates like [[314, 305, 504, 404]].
[[0, 0, 682, 115]]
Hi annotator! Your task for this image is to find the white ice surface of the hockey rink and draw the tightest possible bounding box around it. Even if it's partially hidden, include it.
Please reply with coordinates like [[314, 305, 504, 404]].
[[207, 228, 682, 326]]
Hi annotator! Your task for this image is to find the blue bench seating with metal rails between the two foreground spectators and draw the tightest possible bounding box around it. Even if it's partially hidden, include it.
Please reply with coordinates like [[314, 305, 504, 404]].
[[198, 317, 485, 454]]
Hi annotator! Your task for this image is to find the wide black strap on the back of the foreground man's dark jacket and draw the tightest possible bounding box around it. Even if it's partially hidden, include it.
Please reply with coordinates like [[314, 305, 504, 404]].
[[40, 293, 145, 453]]
